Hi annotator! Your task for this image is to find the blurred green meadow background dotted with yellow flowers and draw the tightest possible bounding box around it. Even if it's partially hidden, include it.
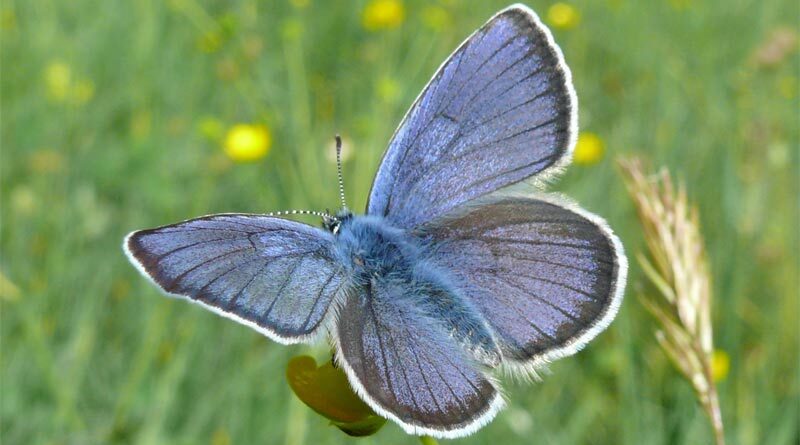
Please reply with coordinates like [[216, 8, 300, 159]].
[[0, 0, 800, 445]]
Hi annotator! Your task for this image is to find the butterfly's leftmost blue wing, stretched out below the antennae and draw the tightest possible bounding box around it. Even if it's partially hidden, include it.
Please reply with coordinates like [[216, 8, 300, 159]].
[[124, 214, 345, 343]]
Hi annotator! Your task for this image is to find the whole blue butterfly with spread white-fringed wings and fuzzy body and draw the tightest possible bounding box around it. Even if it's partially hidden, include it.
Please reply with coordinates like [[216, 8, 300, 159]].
[[124, 5, 627, 437]]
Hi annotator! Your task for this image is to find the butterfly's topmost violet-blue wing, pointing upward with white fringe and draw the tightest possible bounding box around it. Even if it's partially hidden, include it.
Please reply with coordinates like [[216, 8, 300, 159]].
[[367, 5, 577, 228]]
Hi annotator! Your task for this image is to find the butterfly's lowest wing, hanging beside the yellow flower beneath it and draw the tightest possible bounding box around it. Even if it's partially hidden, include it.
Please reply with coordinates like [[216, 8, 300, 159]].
[[335, 280, 503, 437]]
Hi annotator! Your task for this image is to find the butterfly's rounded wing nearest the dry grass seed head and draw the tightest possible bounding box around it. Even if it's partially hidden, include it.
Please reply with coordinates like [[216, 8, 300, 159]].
[[418, 196, 627, 371]]
